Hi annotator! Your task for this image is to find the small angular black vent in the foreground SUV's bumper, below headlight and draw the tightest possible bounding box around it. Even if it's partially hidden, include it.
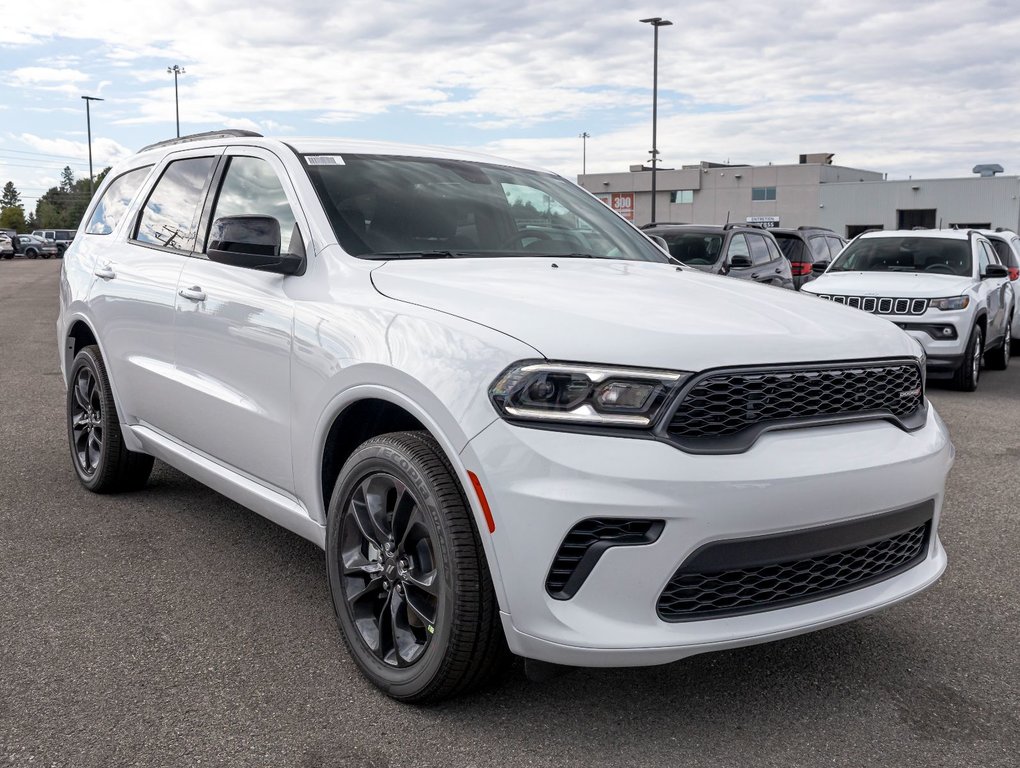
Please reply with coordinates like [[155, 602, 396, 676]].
[[546, 517, 663, 600]]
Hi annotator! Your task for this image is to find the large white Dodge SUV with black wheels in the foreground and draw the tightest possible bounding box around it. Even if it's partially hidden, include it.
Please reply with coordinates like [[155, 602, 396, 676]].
[[57, 132, 953, 701]]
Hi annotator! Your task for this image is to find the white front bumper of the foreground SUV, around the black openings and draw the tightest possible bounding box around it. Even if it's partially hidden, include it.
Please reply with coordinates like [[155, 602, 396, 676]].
[[463, 407, 953, 666]]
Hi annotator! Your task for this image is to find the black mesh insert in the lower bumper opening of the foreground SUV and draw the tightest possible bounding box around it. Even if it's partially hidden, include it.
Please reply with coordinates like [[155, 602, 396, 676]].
[[657, 521, 930, 621]]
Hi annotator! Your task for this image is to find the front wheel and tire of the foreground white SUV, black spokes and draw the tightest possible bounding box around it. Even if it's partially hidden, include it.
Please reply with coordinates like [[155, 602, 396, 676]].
[[326, 431, 510, 703]]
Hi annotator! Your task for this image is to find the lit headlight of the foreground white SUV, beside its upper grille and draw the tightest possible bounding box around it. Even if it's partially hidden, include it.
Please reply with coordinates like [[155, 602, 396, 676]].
[[489, 360, 691, 427]]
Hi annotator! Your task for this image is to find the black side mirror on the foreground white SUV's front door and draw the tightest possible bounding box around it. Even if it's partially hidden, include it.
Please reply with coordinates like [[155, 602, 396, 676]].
[[206, 216, 305, 274]]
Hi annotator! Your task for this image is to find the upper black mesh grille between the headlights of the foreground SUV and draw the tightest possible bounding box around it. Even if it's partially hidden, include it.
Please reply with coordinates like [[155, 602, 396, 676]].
[[668, 363, 924, 442]]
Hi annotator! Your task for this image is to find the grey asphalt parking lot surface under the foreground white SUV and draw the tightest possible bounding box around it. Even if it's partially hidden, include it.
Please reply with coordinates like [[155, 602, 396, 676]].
[[0, 260, 1020, 768]]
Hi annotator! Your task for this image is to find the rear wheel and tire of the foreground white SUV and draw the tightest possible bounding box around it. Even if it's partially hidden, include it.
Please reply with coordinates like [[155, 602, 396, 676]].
[[67, 345, 152, 494]]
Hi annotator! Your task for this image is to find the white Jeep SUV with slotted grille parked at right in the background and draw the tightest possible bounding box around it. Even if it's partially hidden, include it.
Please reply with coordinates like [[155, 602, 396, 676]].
[[803, 229, 1016, 392]]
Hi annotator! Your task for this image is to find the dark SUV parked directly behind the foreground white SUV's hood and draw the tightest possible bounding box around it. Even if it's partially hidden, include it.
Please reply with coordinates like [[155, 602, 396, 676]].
[[642, 224, 794, 289]]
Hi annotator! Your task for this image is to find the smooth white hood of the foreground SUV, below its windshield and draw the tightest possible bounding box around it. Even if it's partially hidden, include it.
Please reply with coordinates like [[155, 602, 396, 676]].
[[372, 258, 917, 370]]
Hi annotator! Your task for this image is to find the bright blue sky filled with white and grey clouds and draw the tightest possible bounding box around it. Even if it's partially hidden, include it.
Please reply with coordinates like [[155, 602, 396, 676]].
[[0, 0, 1020, 210]]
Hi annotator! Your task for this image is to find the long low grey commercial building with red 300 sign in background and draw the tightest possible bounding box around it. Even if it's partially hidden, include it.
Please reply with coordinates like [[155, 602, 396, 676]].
[[578, 155, 1020, 237]]
